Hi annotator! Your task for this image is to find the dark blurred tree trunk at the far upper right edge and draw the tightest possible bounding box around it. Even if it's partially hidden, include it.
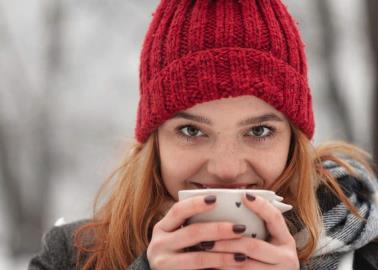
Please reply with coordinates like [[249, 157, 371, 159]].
[[367, 0, 378, 169]]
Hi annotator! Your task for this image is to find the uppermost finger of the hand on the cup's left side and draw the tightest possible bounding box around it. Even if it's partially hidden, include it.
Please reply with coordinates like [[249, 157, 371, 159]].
[[156, 195, 216, 232]]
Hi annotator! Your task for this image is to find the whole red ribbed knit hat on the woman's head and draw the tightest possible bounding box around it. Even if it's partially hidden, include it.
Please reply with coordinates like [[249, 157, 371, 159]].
[[135, 0, 314, 142]]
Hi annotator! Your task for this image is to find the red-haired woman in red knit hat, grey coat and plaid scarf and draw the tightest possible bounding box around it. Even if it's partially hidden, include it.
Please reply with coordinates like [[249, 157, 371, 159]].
[[29, 0, 378, 270]]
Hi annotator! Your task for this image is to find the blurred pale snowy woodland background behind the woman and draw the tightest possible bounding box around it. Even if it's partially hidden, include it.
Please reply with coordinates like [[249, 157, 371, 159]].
[[0, 0, 378, 270]]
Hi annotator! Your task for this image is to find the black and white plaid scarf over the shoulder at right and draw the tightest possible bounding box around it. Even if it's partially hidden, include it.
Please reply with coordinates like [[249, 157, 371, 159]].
[[289, 159, 378, 270]]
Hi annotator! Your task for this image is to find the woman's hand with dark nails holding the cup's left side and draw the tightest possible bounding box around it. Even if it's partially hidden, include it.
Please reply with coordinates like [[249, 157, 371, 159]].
[[147, 195, 246, 270]]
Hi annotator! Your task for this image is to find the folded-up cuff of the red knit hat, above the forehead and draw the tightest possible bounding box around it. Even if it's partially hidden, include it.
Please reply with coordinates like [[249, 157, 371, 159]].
[[135, 47, 314, 142]]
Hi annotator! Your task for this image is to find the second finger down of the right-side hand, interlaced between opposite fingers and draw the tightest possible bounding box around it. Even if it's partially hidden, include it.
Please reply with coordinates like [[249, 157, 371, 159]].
[[211, 237, 284, 265]]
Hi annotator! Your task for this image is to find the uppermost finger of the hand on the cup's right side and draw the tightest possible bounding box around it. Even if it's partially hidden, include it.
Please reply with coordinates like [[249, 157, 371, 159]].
[[243, 195, 295, 245]]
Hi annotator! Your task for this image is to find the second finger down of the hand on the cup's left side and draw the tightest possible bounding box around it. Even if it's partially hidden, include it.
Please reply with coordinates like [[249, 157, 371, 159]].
[[169, 222, 246, 250]]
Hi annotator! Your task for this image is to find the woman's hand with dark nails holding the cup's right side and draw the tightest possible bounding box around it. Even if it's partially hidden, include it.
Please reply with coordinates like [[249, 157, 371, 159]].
[[211, 193, 300, 270]]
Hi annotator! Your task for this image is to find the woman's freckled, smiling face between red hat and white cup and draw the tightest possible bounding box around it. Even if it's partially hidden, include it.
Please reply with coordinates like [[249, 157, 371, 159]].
[[158, 96, 291, 200]]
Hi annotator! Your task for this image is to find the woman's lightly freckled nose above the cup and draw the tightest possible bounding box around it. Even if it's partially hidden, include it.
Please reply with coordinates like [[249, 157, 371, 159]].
[[207, 139, 247, 182]]
